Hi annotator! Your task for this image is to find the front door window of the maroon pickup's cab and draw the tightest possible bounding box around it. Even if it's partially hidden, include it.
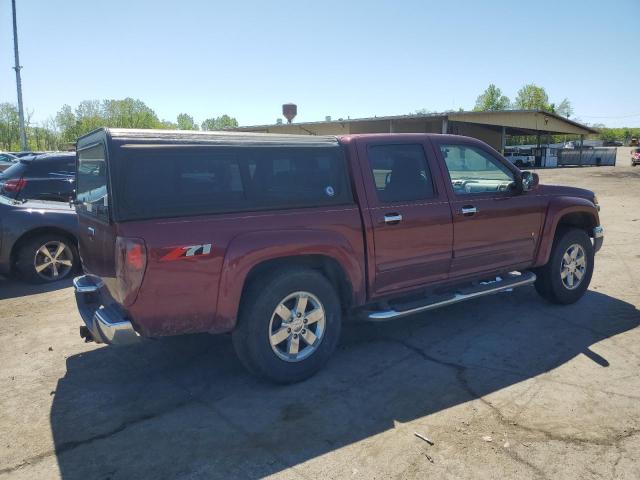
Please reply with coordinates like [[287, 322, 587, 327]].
[[440, 145, 514, 195]]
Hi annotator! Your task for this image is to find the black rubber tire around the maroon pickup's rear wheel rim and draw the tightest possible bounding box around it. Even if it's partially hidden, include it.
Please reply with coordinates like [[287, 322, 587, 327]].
[[233, 268, 342, 384]]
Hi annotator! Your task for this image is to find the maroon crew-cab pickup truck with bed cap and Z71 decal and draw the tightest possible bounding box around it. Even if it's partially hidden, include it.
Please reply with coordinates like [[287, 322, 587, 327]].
[[74, 129, 603, 383]]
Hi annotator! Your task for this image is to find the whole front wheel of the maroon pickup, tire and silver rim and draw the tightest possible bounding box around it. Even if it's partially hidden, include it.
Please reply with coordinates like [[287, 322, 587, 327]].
[[535, 228, 594, 304]]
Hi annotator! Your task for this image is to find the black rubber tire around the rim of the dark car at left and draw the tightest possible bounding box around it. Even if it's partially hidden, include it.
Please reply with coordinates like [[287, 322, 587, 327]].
[[14, 233, 80, 284]]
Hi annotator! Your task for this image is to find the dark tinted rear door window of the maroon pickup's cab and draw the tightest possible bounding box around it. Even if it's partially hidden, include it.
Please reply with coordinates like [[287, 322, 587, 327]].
[[369, 144, 434, 202]]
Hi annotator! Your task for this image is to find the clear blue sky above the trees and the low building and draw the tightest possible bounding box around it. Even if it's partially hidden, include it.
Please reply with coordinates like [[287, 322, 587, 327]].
[[0, 0, 640, 126]]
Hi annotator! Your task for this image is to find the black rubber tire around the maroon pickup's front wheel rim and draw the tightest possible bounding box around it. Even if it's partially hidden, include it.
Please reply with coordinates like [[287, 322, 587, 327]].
[[535, 228, 594, 305]]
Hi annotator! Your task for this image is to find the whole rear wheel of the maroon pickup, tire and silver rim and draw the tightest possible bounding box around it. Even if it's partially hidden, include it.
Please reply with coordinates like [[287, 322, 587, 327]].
[[233, 269, 341, 383]]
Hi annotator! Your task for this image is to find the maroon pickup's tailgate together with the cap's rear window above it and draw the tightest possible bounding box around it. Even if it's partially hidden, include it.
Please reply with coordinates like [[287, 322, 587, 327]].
[[76, 142, 115, 284]]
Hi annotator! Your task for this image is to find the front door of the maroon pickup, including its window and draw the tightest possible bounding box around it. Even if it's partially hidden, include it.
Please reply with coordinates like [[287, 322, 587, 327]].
[[434, 137, 544, 279]]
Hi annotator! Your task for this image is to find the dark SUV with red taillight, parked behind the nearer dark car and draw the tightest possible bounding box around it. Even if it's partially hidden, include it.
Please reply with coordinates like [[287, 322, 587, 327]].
[[0, 152, 76, 202]]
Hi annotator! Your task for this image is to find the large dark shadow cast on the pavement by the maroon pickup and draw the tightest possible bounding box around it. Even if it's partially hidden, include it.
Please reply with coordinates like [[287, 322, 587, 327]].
[[50, 288, 640, 479]]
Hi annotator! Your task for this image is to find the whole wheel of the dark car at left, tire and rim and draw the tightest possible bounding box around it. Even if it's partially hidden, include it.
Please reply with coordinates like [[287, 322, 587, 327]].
[[15, 234, 78, 283]]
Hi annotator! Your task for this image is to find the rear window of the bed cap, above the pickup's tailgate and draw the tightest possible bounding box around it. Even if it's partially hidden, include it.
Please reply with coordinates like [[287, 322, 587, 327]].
[[76, 145, 109, 219]]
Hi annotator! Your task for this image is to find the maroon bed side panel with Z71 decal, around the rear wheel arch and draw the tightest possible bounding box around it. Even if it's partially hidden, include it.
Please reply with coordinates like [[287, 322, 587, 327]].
[[118, 205, 365, 336]]
